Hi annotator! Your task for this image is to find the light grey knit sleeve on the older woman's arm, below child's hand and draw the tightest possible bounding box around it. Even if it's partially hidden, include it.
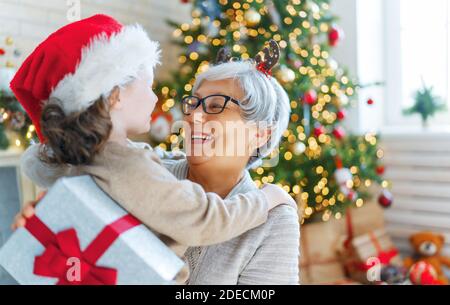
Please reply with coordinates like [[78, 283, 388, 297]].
[[238, 205, 300, 285]]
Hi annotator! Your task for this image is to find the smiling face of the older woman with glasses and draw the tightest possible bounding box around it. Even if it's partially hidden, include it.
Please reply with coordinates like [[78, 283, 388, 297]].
[[185, 79, 258, 168]]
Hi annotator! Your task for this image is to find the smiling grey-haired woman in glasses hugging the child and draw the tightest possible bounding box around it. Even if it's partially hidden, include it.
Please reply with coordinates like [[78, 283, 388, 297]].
[[165, 41, 300, 285]]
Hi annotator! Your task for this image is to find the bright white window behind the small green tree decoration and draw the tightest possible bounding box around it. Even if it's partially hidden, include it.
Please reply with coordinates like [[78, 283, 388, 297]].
[[384, 0, 450, 125]]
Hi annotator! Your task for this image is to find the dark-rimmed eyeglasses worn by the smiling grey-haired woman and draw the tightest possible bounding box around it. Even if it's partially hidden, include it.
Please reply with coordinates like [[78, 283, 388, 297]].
[[181, 94, 240, 115]]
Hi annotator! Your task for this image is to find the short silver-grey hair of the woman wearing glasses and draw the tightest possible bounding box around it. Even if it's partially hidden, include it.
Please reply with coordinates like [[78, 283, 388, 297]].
[[192, 60, 291, 167]]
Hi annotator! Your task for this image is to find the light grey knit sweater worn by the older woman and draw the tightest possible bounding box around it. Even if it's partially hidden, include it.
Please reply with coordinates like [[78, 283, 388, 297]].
[[163, 159, 300, 285]]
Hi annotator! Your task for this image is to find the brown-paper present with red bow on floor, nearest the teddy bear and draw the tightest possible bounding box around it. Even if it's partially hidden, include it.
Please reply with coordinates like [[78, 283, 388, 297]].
[[338, 229, 403, 284]]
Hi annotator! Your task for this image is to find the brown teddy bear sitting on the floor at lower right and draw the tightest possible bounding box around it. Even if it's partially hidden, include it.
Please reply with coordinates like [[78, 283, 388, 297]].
[[404, 232, 450, 285]]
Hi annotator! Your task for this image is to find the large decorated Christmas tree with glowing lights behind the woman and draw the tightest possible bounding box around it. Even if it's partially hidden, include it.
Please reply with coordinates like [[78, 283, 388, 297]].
[[156, 0, 392, 221]]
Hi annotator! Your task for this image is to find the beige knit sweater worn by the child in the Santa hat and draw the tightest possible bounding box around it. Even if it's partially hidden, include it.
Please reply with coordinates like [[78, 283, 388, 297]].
[[22, 142, 268, 256]]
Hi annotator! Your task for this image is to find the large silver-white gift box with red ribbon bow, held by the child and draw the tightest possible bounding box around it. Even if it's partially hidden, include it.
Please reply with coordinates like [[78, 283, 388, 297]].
[[0, 176, 184, 285]]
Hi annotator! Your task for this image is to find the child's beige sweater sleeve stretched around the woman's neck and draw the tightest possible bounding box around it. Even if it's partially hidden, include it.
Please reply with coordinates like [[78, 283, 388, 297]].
[[108, 152, 268, 246]]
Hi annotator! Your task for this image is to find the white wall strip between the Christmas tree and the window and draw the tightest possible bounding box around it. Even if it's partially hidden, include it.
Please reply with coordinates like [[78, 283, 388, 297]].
[[331, 0, 385, 133]]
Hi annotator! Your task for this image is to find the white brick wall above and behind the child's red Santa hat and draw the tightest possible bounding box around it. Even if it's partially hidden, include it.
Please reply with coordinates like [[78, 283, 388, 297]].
[[0, 0, 191, 77]]
